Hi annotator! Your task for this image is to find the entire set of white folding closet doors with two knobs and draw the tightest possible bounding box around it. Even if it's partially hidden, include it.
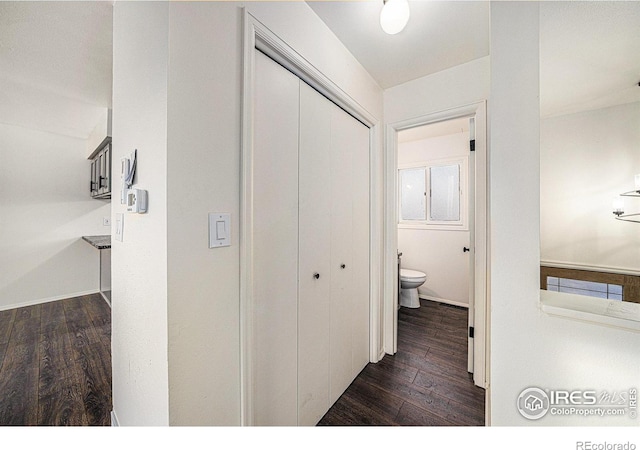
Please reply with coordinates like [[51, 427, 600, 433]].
[[251, 52, 369, 425]]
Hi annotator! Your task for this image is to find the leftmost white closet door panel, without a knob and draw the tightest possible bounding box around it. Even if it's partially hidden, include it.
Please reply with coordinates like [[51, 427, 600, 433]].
[[252, 52, 299, 425]]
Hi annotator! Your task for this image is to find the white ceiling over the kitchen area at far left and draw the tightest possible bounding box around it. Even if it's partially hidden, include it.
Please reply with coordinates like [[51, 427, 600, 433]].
[[0, 1, 113, 138]]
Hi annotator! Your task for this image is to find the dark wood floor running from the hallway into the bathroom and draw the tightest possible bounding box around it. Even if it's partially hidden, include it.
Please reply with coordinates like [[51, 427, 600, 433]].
[[318, 300, 484, 426]]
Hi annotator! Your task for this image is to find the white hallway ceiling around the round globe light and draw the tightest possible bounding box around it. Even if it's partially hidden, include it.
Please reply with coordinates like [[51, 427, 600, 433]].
[[307, 0, 489, 89]]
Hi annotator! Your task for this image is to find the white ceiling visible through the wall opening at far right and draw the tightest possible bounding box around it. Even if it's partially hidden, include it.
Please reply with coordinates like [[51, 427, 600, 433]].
[[540, 1, 640, 117]]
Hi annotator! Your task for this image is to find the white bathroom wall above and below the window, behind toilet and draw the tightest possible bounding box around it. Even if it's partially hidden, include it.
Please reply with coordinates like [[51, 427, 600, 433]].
[[398, 132, 470, 306]]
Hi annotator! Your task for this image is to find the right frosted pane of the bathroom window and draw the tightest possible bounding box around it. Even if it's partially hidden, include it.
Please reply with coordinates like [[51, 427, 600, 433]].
[[429, 164, 460, 222]]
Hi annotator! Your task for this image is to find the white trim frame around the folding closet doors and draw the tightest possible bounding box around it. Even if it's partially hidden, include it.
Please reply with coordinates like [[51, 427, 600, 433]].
[[240, 8, 383, 425]]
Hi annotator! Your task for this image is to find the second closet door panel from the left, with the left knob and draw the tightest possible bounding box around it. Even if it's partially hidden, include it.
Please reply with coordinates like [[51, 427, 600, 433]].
[[298, 82, 332, 425]]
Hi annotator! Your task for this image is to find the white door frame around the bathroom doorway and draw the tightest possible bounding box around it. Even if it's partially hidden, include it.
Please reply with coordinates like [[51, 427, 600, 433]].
[[384, 101, 489, 388]]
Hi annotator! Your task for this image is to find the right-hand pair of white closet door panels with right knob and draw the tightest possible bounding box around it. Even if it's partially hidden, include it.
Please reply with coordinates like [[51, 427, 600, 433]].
[[330, 105, 369, 404]]
